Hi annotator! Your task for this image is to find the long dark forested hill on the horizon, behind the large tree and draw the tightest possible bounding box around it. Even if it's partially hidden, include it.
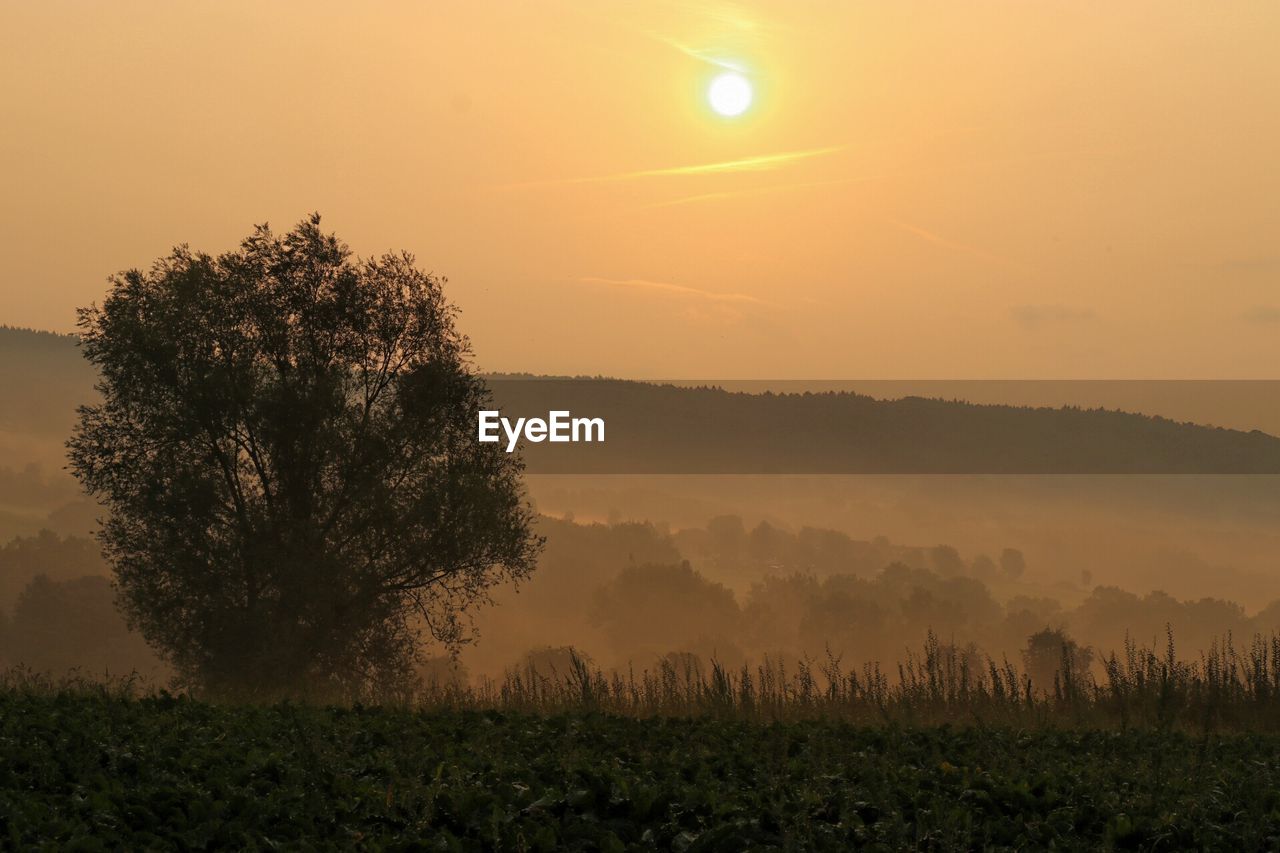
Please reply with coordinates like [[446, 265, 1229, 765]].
[[0, 328, 1280, 474]]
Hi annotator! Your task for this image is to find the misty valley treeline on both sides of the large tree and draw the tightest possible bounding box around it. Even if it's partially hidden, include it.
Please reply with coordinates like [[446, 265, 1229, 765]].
[[0, 516, 1280, 684]]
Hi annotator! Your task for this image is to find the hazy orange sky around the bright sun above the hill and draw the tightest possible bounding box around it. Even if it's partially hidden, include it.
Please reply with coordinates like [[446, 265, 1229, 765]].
[[0, 0, 1280, 378]]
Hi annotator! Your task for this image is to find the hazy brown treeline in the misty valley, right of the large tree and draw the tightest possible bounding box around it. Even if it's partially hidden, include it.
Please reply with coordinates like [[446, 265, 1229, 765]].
[[463, 516, 1280, 672]]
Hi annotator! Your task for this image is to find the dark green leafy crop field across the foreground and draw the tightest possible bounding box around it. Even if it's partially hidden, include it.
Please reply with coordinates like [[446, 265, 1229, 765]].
[[0, 686, 1280, 850]]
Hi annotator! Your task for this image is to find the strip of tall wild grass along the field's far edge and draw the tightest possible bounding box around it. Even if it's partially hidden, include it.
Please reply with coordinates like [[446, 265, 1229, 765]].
[[416, 633, 1280, 733]]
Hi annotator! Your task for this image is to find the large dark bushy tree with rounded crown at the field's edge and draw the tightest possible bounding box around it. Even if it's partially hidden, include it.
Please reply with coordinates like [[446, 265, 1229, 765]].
[[69, 216, 540, 694]]
